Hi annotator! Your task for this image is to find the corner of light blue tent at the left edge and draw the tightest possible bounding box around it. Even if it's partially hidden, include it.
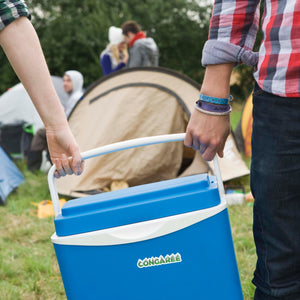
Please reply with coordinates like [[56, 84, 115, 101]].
[[0, 146, 24, 205]]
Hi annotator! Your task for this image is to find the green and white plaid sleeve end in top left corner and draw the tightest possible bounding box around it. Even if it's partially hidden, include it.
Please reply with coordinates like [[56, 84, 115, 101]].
[[0, 0, 30, 30]]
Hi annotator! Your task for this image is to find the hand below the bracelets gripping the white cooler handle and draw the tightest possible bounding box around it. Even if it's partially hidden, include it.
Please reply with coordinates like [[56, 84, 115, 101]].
[[184, 109, 230, 161]]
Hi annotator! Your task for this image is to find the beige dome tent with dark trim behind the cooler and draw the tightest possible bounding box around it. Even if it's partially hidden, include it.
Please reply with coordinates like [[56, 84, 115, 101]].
[[57, 68, 249, 196]]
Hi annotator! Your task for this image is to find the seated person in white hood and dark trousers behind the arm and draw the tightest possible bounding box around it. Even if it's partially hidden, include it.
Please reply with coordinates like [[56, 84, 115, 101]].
[[27, 70, 84, 171]]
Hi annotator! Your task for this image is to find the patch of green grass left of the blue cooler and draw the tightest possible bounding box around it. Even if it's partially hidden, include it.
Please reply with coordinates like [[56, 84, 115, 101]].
[[0, 165, 65, 300]]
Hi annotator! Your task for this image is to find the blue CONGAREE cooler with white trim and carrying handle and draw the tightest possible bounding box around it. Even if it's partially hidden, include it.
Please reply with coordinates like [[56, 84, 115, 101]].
[[48, 134, 243, 300]]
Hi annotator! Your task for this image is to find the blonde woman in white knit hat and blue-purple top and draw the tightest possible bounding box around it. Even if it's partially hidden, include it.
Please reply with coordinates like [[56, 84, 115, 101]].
[[100, 26, 128, 75]]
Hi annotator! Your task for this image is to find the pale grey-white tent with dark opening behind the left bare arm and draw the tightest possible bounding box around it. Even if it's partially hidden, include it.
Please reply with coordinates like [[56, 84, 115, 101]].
[[0, 76, 67, 154]]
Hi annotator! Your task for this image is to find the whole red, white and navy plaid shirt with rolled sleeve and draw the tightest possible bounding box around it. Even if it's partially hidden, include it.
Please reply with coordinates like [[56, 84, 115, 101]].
[[202, 0, 300, 97]]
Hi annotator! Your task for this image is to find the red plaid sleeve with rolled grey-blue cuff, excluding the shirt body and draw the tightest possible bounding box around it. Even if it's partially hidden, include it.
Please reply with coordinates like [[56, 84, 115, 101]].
[[202, 0, 260, 66]]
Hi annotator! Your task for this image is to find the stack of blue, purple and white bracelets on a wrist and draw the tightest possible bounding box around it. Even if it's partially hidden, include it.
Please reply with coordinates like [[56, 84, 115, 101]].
[[196, 94, 233, 116]]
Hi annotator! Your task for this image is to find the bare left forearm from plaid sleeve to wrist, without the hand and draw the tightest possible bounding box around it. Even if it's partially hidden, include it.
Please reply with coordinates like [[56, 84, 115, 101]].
[[0, 17, 66, 128]]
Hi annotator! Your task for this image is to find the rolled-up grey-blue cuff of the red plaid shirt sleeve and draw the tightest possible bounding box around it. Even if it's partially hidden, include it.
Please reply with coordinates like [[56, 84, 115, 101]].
[[202, 40, 258, 67]]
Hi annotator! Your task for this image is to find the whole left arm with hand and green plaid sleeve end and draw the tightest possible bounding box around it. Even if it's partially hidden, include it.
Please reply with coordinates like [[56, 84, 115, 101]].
[[0, 0, 83, 178]]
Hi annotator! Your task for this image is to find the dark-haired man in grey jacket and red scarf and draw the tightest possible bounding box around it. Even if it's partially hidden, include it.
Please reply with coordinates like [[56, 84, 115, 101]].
[[122, 21, 159, 68]]
